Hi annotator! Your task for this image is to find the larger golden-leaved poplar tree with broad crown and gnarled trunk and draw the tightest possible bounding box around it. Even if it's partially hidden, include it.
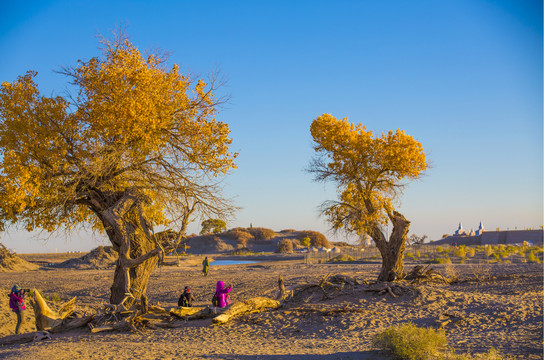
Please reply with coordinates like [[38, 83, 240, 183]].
[[0, 33, 236, 304]]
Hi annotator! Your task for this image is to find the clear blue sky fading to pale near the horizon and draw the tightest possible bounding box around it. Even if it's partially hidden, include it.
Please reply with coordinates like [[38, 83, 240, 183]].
[[0, 0, 543, 252]]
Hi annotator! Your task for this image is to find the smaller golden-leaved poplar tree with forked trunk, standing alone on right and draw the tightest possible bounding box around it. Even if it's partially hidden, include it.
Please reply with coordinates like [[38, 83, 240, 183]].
[[308, 114, 428, 281]]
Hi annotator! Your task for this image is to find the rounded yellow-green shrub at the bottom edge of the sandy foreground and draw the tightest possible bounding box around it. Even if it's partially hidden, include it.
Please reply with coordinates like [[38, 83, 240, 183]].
[[373, 323, 448, 360]]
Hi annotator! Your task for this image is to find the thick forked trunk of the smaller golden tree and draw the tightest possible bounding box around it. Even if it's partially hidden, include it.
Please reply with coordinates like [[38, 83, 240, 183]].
[[370, 211, 410, 281]]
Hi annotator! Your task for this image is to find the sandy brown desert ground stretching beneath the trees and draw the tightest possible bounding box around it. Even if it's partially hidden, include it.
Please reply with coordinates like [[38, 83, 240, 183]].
[[0, 255, 543, 360]]
